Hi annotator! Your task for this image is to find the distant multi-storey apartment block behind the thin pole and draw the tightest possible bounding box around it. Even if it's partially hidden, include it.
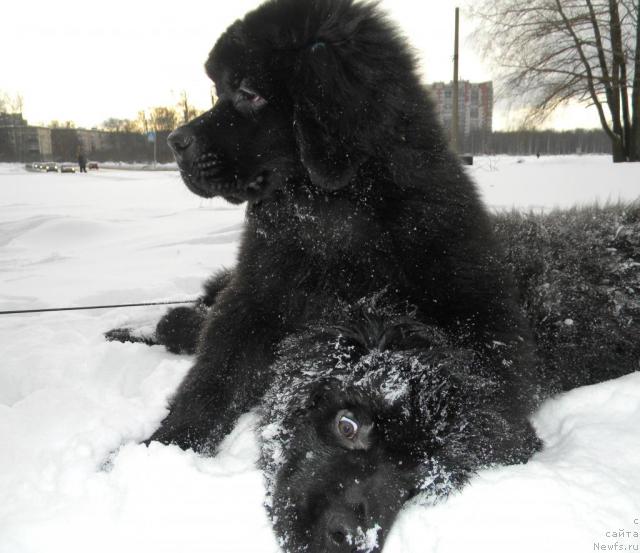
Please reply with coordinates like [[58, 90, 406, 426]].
[[429, 81, 493, 137]]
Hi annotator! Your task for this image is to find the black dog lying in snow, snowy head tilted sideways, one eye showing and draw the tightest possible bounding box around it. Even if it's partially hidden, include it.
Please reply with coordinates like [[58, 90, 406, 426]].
[[261, 205, 640, 553]]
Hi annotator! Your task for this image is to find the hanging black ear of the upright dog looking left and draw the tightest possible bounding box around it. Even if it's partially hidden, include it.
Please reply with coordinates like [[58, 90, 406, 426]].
[[291, 41, 368, 190]]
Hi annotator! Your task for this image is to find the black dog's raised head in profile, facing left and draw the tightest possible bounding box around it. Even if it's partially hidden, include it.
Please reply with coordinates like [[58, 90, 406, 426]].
[[169, 0, 419, 202]]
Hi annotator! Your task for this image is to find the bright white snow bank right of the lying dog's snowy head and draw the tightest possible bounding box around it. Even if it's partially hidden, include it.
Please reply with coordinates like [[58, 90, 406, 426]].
[[385, 373, 640, 553]]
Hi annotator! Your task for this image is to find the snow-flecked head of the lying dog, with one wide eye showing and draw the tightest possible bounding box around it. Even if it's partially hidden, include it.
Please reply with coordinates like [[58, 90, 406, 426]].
[[262, 303, 538, 553]]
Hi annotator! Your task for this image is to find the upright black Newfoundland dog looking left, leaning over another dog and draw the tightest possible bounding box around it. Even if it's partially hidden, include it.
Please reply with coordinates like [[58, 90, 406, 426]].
[[109, 0, 534, 458]]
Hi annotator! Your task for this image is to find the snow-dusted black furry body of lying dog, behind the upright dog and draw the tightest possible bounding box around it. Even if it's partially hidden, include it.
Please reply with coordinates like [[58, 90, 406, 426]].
[[494, 202, 640, 397]]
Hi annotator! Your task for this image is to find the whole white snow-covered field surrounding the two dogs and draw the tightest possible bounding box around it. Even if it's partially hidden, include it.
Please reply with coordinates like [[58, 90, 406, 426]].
[[0, 156, 640, 553]]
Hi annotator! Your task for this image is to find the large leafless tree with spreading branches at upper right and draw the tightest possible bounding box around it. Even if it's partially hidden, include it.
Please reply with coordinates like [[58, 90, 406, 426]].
[[473, 0, 640, 161]]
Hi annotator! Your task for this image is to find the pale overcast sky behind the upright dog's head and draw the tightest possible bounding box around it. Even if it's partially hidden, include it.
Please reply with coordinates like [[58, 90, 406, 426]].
[[0, 0, 597, 128]]
